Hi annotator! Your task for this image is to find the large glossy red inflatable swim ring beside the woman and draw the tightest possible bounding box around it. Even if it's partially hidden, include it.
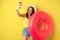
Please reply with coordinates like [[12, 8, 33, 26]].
[[28, 11, 52, 40]]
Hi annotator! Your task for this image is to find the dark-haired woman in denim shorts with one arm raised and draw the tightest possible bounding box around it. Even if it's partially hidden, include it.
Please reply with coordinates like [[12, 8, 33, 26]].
[[16, 2, 35, 40]]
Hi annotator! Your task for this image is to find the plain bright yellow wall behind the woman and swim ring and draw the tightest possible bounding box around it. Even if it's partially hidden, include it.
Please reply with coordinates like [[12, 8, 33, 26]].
[[0, 0, 60, 40]]
